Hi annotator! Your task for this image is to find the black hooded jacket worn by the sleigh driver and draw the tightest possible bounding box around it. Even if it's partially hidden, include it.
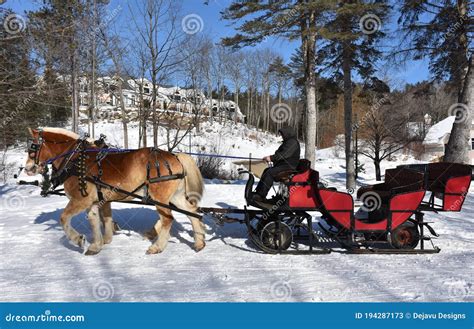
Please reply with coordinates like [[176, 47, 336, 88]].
[[270, 127, 300, 169]]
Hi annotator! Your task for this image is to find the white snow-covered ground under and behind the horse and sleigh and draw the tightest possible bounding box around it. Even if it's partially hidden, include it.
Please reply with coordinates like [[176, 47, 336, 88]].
[[0, 120, 474, 301]]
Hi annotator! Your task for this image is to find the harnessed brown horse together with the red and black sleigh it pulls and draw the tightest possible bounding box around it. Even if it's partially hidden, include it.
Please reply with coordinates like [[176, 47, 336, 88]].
[[25, 128, 472, 255]]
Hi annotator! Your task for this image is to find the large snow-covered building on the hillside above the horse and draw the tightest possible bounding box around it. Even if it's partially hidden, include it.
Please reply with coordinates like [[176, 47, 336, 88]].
[[80, 76, 244, 122]]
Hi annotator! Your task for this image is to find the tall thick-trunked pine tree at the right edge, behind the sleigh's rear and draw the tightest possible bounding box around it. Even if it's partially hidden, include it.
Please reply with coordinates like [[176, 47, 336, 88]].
[[395, 0, 474, 163]]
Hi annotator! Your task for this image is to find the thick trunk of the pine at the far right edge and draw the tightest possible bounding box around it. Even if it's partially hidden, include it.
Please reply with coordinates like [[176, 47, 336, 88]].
[[444, 55, 474, 164]]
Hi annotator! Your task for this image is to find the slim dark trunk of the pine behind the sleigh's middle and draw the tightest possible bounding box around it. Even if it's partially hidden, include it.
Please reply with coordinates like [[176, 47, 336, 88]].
[[342, 43, 355, 190]]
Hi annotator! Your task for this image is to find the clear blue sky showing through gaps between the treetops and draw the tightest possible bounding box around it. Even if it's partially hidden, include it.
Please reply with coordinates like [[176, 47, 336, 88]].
[[2, 0, 429, 85]]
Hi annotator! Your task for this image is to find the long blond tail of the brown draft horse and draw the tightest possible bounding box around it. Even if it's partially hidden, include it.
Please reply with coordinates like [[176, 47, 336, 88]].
[[176, 153, 204, 207]]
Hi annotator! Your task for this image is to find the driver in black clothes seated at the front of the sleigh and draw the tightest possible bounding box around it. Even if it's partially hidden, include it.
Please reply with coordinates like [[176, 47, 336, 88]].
[[253, 126, 300, 202]]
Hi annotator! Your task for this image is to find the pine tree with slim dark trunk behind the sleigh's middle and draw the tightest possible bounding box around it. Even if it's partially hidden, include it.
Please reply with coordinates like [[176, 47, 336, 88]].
[[318, 0, 389, 190]]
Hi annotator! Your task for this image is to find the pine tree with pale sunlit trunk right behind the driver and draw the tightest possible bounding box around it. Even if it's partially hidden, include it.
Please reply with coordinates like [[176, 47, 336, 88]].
[[223, 0, 335, 165]]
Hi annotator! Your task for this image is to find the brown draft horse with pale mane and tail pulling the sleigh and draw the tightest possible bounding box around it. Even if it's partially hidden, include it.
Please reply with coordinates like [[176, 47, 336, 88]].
[[25, 128, 206, 255]]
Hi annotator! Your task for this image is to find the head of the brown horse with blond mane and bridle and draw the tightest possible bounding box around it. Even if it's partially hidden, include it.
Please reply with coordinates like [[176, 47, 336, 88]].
[[25, 128, 79, 176]]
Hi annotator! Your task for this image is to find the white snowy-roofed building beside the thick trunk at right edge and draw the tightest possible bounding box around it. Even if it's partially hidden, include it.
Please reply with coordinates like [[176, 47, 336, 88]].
[[423, 116, 474, 165]]
